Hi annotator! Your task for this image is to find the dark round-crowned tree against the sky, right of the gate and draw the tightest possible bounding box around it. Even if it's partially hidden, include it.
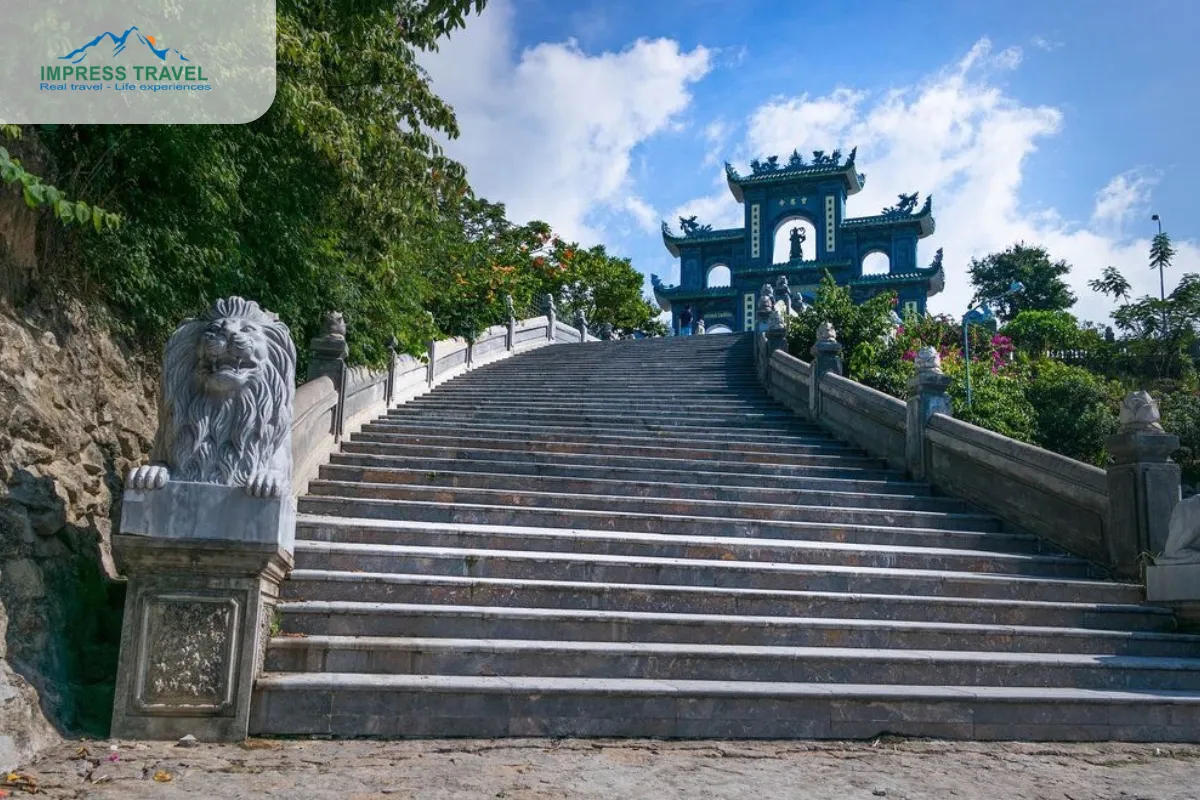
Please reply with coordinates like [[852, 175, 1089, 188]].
[[967, 242, 1075, 320]]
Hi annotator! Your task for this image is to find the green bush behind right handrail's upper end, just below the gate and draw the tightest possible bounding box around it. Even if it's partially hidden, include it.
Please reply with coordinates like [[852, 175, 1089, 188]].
[[787, 272, 895, 380]]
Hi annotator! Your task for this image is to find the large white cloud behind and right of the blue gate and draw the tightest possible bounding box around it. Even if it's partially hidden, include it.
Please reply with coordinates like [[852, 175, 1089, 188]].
[[680, 33, 1200, 320]]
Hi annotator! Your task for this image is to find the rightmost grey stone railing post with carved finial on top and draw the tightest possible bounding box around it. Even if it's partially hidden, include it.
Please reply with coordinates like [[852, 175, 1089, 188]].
[[1108, 391, 1180, 577]]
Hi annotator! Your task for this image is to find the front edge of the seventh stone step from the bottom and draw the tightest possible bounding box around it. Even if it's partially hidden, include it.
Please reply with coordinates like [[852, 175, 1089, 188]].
[[300, 494, 1038, 542]]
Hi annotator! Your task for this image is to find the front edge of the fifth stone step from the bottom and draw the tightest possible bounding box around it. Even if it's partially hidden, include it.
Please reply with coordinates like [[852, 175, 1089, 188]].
[[288, 540, 1123, 589]]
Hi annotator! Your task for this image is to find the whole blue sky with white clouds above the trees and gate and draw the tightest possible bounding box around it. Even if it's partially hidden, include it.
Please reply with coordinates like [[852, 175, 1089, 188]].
[[426, 0, 1200, 319]]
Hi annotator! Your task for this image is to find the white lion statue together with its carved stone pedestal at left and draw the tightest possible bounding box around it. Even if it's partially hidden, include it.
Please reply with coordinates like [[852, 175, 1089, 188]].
[[112, 297, 297, 741]]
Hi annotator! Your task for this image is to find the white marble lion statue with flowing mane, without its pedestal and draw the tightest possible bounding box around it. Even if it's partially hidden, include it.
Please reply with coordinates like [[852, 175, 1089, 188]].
[[128, 297, 296, 498]]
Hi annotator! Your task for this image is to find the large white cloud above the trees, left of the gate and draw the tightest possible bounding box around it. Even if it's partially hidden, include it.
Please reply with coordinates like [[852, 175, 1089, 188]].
[[422, 0, 710, 242]]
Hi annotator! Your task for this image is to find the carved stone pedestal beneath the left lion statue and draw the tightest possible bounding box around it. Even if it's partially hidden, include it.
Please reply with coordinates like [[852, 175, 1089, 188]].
[[113, 482, 295, 741]]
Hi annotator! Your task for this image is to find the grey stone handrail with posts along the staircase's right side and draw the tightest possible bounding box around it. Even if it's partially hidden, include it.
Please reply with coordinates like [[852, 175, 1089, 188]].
[[755, 332, 1178, 577]]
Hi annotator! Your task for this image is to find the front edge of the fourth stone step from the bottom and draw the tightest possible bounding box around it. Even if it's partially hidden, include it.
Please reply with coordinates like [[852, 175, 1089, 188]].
[[289, 569, 1171, 618]]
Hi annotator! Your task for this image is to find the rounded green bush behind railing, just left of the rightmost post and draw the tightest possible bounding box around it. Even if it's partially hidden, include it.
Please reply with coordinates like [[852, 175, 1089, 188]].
[[1025, 359, 1122, 465]]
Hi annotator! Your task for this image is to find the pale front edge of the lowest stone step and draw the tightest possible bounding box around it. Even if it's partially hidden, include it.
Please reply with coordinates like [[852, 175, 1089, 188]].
[[254, 673, 1200, 705]]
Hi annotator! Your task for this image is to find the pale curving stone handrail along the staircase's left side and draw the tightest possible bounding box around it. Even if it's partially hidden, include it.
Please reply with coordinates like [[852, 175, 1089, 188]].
[[285, 317, 576, 495]]
